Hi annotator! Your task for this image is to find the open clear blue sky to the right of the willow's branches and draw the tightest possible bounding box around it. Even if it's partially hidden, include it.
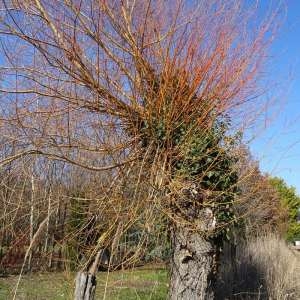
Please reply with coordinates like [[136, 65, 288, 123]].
[[251, 0, 300, 194]]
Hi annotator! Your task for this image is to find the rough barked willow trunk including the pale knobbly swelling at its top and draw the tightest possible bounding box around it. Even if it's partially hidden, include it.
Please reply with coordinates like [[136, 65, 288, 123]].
[[169, 186, 216, 300]]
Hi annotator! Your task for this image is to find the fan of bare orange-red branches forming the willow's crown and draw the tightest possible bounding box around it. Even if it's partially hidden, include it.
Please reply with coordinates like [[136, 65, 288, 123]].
[[0, 0, 274, 170]]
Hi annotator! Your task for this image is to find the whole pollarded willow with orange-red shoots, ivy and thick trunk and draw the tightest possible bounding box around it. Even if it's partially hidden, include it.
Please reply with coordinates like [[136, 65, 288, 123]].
[[0, 0, 274, 299]]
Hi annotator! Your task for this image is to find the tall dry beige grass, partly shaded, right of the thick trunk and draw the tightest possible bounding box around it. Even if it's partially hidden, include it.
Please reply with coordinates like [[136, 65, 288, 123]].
[[218, 234, 300, 300]]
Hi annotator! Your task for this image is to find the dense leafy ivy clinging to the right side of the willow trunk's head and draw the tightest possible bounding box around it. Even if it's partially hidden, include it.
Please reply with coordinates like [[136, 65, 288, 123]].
[[176, 118, 238, 244]]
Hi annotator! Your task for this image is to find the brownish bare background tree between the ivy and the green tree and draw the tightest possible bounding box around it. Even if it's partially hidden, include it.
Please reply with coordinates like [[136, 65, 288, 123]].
[[234, 145, 288, 237]]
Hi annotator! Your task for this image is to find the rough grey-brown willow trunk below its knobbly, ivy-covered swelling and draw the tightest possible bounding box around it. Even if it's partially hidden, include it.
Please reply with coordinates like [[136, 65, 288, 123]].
[[169, 225, 215, 300]]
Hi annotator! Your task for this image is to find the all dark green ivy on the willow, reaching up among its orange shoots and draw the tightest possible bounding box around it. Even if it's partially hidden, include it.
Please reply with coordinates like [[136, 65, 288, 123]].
[[138, 78, 239, 243]]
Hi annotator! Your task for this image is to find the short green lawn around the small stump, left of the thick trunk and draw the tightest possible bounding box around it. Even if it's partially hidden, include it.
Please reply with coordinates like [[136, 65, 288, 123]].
[[0, 268, 168, 300]]
